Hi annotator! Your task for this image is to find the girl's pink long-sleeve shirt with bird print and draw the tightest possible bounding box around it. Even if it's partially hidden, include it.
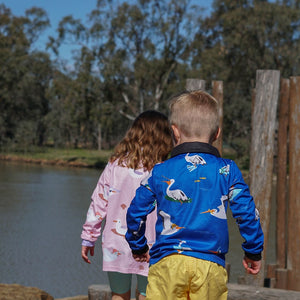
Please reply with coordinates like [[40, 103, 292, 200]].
[[81, 161, 156, 276]]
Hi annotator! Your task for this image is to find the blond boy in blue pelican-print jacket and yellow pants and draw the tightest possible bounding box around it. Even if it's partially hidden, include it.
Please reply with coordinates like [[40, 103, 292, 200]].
[[126, 91, 264, 300]]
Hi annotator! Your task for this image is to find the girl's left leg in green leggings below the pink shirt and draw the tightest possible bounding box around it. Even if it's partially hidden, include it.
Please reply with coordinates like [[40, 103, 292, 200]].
[[107, 272, 131, 300]]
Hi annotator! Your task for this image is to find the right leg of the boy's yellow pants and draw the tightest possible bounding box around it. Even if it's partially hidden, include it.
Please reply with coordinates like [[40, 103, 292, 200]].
[[189, 259, 228, 300]]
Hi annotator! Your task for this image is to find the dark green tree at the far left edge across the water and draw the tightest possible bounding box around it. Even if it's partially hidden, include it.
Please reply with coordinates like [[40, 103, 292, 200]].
[[0, 4, 52, 146]]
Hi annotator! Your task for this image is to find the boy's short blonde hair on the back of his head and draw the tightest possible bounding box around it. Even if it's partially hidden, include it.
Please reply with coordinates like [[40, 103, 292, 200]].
[[169, 90, 219, 142]]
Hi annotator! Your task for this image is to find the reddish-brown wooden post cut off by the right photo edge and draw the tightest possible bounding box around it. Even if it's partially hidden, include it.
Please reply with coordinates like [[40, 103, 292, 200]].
[[287, 77, 300, 291]]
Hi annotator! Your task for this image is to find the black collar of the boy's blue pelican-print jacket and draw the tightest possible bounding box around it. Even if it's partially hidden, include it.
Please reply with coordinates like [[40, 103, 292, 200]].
[[171, 142, 221, 157]]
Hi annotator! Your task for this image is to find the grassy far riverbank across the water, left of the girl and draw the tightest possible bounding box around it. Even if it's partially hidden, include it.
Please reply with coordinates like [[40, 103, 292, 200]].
[[0, 147, 111, 169]]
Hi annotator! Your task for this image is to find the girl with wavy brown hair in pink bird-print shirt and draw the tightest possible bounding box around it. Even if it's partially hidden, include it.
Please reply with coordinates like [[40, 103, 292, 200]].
[[81, 111, 172, 300]]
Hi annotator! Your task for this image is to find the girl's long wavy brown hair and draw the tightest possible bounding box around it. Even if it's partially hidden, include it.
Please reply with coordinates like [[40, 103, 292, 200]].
[[110, 110, 172, 171]]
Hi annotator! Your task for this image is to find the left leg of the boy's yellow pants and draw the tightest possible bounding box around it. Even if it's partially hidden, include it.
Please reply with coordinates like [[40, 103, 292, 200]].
[[146, 254, 189, 300]]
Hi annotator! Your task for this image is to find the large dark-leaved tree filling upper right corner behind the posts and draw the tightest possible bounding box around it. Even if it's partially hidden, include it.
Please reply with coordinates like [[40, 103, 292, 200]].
[[193, 0, 300, 161]]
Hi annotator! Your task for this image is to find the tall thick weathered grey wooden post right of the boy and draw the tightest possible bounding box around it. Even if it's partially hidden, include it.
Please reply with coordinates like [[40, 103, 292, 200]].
[[246, 70, 280, 286]]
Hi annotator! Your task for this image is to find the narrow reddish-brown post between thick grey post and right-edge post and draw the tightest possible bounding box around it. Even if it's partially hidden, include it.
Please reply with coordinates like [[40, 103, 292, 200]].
[[276, 79, 290, 272]]
